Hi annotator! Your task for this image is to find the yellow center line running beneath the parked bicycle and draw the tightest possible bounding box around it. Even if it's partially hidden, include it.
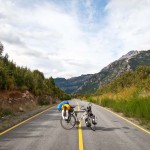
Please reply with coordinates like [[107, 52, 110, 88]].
[[77, 103, 84, 150]]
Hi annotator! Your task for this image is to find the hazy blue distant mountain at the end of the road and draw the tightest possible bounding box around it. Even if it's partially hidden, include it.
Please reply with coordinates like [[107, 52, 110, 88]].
[[54, 74, 92, 94]]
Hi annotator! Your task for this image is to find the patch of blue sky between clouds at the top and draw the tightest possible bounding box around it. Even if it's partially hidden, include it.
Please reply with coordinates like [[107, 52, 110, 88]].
[[16, 0, 108, 32]]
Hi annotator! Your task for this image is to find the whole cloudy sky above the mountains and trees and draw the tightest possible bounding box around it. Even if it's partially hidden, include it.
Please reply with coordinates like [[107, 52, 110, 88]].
[[0, 0, 150, 78]]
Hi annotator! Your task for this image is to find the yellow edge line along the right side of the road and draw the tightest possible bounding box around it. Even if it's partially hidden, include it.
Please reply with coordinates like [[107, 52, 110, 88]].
[[98, 105, 150, 134]]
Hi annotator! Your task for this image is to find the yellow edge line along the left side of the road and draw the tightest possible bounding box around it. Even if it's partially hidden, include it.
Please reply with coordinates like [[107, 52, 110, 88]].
[[0, 106, 54, 136]]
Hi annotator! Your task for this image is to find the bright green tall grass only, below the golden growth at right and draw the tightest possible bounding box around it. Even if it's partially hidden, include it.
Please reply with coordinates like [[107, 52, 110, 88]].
[[101, 97, 150, 121]]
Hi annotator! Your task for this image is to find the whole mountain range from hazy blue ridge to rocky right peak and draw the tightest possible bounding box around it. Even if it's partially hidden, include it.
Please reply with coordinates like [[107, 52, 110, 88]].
[[54, 50, 150, 94]]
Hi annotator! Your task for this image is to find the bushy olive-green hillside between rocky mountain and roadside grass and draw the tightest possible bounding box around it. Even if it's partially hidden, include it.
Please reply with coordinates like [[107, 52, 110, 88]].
[[96, 66, 150, 94]]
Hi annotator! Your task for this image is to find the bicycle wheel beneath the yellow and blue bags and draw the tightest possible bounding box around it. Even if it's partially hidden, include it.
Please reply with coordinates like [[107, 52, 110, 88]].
[[60, 115, 76, 130]]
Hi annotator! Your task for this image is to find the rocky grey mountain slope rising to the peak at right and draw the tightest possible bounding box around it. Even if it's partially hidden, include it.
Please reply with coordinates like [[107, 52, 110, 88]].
[[75, 50, 150, 94]]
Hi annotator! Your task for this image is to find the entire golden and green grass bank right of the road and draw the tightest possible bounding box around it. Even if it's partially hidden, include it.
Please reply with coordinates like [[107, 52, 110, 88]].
[[87, 88, 150, 128]]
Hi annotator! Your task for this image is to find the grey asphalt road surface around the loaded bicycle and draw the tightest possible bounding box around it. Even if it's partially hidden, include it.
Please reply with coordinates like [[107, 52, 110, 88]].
[[0, 100, 150, 150]]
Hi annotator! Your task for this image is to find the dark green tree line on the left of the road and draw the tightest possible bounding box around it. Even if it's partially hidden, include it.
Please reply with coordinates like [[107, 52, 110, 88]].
[[0, 43, 70, 99]]
